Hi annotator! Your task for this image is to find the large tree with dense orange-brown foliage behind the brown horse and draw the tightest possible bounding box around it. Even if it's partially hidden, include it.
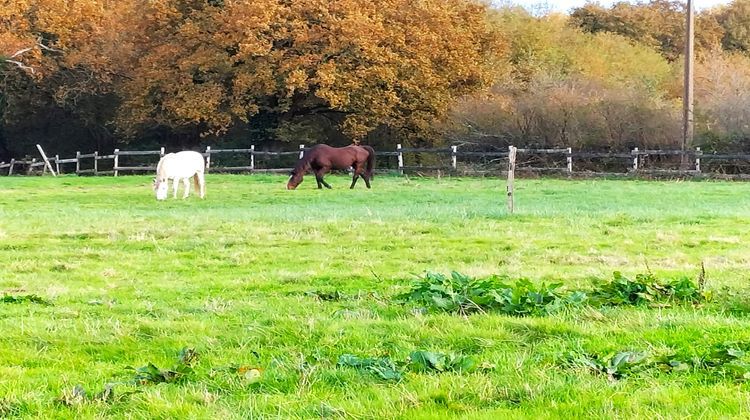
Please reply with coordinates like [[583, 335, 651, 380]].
[[118, 0, 502, 146]]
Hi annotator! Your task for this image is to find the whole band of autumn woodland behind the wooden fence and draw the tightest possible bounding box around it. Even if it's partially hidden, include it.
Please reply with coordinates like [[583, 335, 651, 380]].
[[0, 0, 750, 160]]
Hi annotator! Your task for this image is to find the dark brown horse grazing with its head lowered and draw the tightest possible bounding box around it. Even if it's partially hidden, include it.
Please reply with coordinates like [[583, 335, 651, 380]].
[[286, 144, 375, 190]]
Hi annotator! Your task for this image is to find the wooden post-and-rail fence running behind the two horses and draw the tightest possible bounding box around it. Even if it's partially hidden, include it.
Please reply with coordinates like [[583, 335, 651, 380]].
[[0, 144, 750, 176]]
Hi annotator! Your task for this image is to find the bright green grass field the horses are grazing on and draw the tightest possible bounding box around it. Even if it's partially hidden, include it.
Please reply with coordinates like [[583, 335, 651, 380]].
[[0, 174, 750, 419]]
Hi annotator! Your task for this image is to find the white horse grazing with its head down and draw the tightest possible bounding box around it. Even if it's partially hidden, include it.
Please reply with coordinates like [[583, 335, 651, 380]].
[[154, 150, 206, 200]]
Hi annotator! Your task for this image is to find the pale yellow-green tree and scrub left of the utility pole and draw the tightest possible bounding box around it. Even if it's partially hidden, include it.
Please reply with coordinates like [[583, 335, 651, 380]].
[[448, 8, 679, 150]]
